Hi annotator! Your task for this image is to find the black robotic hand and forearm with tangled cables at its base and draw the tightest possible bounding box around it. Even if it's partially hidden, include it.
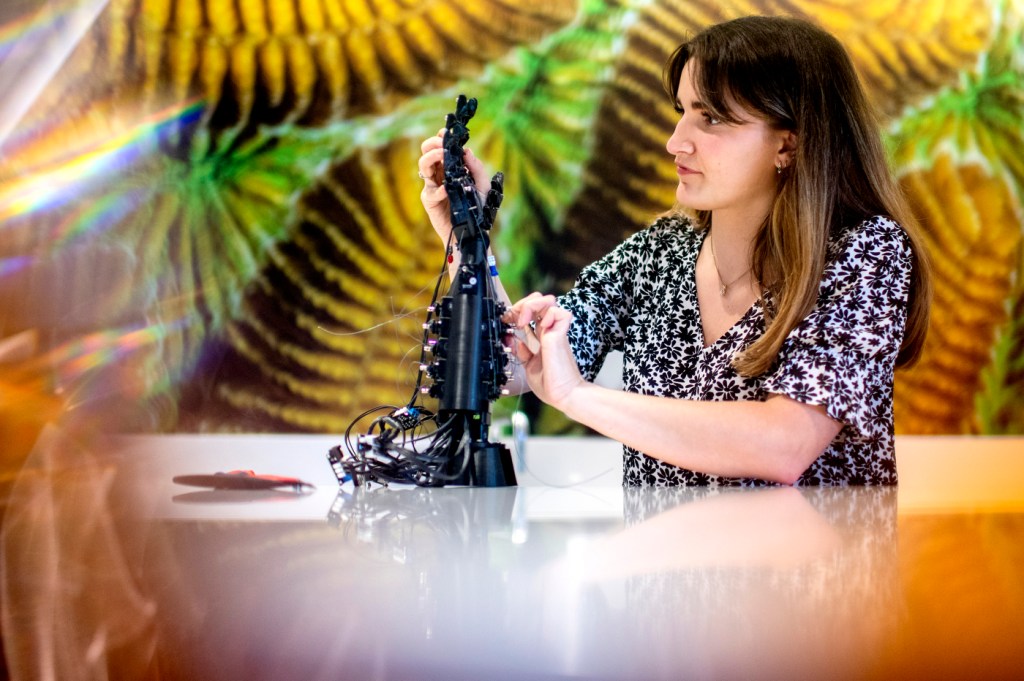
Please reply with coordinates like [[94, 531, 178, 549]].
[[328, 95, 516, 486]]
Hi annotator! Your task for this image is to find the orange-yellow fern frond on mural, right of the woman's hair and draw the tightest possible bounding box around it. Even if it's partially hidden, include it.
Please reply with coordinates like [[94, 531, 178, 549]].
[[893, 156, 1021, 434]]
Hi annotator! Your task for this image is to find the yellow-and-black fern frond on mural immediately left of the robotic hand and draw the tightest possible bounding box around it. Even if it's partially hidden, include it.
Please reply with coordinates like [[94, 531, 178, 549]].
[[180, 140, 440, 432]]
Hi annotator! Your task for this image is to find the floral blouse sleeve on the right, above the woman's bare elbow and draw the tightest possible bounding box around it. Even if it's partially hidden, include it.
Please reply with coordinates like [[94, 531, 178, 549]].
[[762, 217, 913, 440]]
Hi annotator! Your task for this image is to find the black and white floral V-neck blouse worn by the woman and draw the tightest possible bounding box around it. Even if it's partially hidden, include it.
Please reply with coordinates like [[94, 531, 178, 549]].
[[559, 216, 912, 486]]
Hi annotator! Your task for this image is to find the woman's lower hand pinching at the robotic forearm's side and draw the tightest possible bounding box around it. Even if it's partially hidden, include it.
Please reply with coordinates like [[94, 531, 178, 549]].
[[511, 293, 586, 409]]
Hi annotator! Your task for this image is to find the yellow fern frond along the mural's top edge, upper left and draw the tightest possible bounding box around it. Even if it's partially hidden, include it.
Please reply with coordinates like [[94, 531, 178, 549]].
[[12, 0, 577, 147]]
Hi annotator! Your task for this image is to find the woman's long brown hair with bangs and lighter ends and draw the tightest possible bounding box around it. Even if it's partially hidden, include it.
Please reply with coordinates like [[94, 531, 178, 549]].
[[664, 16, 931, 376]]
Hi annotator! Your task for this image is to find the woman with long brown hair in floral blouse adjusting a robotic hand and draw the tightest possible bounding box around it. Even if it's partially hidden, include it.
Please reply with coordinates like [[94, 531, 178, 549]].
[[420, 16, 929, 485]]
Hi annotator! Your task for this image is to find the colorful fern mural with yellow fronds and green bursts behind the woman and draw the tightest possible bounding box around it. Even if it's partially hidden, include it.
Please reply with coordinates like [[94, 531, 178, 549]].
[[0, 0, 1024, 441]]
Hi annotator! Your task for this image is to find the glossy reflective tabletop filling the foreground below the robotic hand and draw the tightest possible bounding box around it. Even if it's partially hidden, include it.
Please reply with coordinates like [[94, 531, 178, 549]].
[[2, 433, 1024, 679]]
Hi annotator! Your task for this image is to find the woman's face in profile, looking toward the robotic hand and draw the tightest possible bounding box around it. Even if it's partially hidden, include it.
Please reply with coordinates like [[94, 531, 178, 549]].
[[666, 61, 793, 224]]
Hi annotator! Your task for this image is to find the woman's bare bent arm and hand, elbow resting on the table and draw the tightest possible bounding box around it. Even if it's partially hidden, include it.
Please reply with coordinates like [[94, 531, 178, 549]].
[[516, 297, 842, 484]]
